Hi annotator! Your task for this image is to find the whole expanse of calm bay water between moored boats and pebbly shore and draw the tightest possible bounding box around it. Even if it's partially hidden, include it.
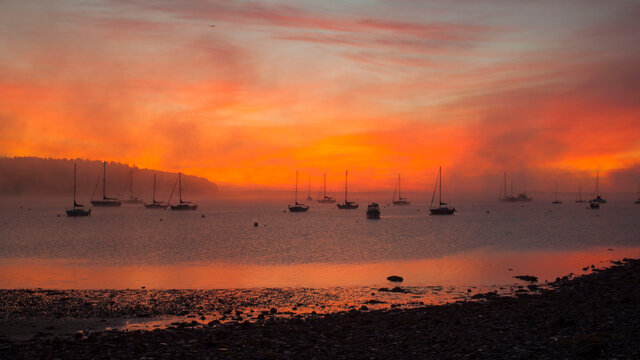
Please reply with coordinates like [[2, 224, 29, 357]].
[[0, 202, 640, 289]]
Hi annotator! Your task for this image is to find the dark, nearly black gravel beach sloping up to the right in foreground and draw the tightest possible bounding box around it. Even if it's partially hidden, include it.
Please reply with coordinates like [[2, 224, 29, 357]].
[[0, 259, 640, 359]]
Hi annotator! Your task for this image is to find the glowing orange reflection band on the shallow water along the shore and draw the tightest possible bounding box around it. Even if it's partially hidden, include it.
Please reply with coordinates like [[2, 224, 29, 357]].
[[0, 248, 640, 289]]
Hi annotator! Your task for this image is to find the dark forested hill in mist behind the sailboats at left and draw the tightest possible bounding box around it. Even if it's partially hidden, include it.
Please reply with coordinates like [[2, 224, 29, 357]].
[[0, 157, 218, 201]]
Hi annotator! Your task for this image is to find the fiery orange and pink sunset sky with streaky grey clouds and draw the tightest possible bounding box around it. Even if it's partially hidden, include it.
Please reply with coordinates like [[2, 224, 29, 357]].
[[0, 0, 640, 193]]
